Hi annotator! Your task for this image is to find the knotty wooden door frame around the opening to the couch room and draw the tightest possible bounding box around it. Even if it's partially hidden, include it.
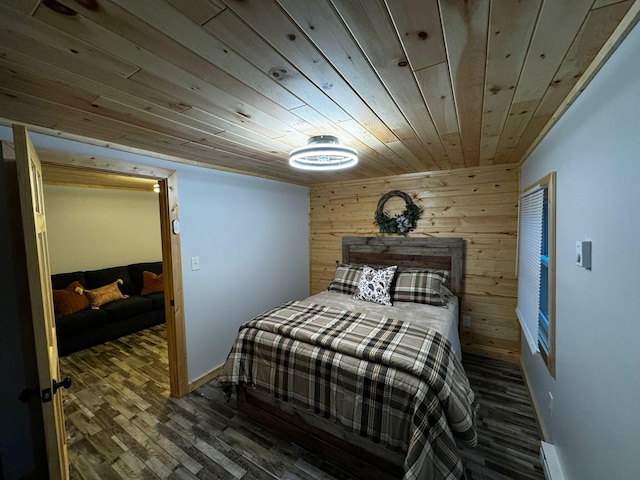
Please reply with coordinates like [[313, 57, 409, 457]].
[[37, 148, 189, 398]]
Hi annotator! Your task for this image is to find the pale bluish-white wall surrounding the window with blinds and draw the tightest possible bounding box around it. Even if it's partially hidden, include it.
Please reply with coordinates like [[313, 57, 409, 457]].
[[520, 19, 640, 480]]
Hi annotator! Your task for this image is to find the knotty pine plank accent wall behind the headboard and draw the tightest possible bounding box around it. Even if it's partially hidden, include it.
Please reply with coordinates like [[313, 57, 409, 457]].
[[310, 164, 520, 363]]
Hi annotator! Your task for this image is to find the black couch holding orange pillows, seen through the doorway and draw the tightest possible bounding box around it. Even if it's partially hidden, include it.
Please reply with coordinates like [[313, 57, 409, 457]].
[[51, 262, 165, 356]]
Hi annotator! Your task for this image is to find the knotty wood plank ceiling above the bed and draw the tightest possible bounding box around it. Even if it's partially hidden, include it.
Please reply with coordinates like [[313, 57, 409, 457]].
[[0, 0, 640, 185]]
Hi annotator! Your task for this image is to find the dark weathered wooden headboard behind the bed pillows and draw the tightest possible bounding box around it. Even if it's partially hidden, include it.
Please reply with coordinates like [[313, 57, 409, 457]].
[[342, 237, 464, 295]]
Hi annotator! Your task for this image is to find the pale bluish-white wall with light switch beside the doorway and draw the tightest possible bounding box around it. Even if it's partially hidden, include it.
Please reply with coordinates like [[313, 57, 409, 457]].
[[0, 127, 309, 381]]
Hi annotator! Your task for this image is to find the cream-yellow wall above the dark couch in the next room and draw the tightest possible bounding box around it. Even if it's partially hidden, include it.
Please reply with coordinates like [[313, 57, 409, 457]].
[[44, 185, 162, 273]]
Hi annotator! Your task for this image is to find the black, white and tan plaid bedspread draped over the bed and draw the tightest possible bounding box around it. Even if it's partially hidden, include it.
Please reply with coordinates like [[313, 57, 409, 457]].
[[218, 302, 477, 480]]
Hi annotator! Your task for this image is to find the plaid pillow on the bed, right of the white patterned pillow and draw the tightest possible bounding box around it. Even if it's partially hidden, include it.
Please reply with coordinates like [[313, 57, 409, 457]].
[[391, 268, 449, 307]]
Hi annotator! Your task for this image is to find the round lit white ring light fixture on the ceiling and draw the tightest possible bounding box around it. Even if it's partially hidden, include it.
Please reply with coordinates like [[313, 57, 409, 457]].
[[289, 135, 358, 170]]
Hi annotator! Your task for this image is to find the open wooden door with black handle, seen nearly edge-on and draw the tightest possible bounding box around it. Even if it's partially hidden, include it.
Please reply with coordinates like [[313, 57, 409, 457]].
[[13, 125, 69, 480]]
